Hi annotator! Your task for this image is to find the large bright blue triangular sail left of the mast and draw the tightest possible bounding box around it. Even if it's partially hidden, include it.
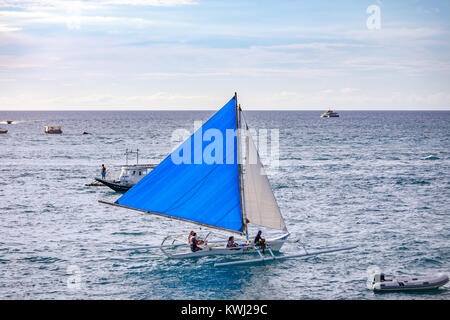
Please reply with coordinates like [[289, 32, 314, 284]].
[[116, 97, 243, 233]]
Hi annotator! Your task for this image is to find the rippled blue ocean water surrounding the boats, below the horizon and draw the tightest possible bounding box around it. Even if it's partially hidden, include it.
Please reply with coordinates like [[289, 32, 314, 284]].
[[0, 111, 450, 299]]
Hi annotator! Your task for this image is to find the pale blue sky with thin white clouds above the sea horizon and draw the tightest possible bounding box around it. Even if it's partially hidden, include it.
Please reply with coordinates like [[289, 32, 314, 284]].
[[0, 0, 450, 110]]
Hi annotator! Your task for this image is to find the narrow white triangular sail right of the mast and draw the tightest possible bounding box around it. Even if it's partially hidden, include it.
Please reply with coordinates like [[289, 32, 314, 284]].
[[244, 119, 287, 231]]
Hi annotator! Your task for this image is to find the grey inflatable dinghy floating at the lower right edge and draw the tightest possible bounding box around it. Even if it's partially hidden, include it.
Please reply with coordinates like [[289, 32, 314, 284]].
[[372, 273, 449, 292]]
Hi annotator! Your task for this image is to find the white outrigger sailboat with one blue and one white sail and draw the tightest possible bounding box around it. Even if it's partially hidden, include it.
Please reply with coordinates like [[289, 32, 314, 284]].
[[99, 94, 356, 267]]
